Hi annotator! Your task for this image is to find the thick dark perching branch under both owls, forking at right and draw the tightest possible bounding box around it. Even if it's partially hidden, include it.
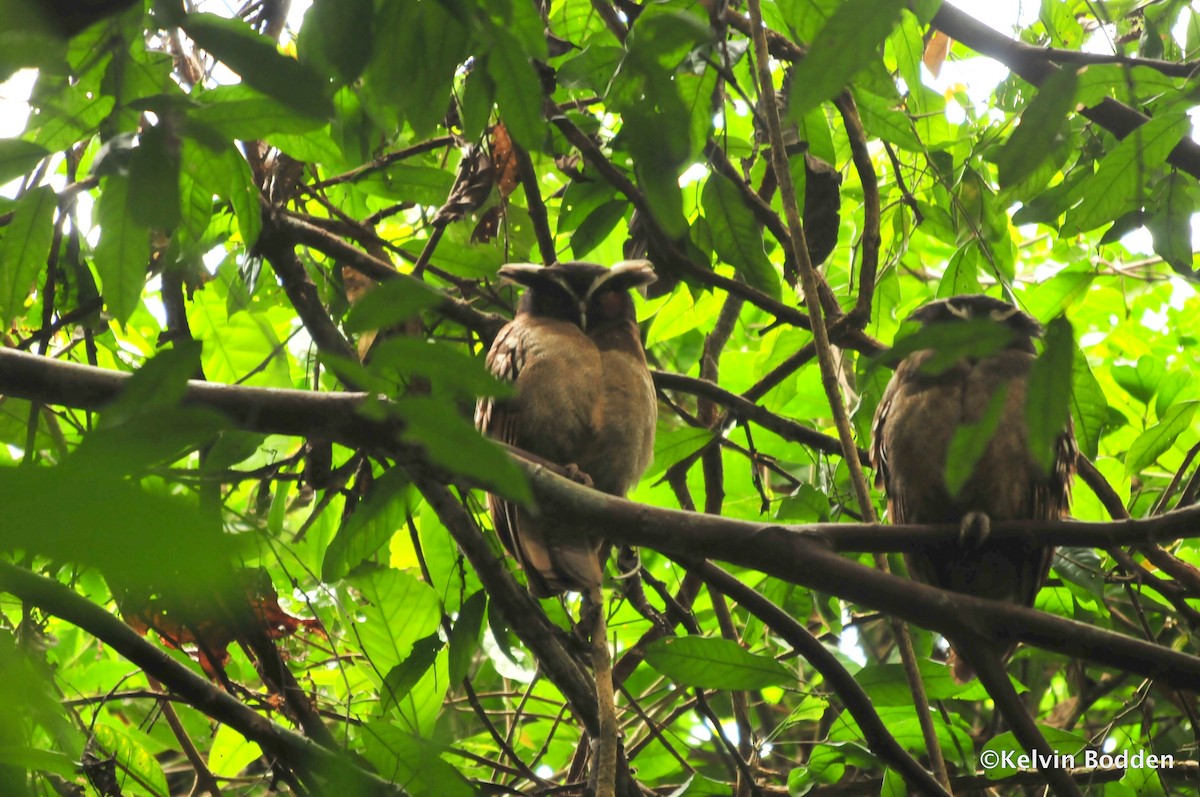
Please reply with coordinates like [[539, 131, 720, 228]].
[[7, 349, 1200, 691]]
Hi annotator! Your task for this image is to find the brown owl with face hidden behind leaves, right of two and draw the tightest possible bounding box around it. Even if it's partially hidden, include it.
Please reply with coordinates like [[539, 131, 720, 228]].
[[871, 295, 1078, 679]]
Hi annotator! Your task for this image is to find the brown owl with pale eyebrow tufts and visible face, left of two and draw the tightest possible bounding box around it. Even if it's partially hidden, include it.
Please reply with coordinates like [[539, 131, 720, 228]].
[[475, 260, 658, 597]]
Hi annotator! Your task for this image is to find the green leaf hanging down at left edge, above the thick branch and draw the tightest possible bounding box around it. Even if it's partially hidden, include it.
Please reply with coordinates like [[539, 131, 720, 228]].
[[0, 186, 59, 328]]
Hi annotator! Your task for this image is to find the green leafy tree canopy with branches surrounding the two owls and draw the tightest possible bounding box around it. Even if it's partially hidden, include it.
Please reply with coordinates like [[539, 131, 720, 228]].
[[0, 0, 1200, 797]]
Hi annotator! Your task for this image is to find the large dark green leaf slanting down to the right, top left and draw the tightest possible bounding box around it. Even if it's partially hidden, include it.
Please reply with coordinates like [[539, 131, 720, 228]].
[[182, 13, 334, 119]]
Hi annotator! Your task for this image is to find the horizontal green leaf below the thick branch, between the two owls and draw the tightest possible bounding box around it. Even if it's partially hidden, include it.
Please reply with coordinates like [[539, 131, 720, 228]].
[[646, 636, 796, 690]]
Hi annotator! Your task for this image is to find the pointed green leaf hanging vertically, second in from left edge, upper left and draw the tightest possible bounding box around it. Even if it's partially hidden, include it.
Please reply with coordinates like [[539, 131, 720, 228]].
[[95, 174, 150, 323]]
